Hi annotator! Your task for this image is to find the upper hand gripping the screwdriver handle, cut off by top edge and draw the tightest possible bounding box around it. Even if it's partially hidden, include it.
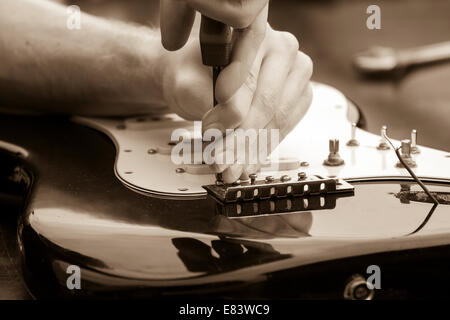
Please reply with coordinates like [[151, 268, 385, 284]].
[[160, 0, 269, 103]]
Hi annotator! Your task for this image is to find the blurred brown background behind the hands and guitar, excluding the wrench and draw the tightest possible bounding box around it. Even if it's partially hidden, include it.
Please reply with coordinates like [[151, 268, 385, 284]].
[[58, 0, 450, 152]]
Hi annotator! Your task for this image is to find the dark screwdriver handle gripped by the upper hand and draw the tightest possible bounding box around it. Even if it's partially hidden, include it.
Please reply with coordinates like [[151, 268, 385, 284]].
[[200, 15, 233, 67]]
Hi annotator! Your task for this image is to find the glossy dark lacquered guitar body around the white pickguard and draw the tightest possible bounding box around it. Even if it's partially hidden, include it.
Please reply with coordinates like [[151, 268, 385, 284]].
[[0, 83, 450, 299]]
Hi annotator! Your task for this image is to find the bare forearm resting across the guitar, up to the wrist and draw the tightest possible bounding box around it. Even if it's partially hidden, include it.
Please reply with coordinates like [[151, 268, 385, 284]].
[[0, 0, 164, 115]]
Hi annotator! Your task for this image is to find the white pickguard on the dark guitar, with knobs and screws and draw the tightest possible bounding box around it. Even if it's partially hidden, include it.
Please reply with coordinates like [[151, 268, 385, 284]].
[[74, 84, 450, 199]]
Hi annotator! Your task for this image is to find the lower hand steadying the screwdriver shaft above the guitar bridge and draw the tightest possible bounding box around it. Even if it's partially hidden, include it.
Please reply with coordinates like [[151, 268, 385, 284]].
[[160, 26, 312, 183]]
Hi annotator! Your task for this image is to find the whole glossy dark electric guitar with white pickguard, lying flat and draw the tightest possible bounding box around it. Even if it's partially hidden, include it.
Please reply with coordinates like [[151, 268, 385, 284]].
[[0, 84, 450, 299]]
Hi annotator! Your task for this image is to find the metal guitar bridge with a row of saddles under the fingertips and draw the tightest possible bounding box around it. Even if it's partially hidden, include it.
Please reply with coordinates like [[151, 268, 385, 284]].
[[203, 176, 354, 203]]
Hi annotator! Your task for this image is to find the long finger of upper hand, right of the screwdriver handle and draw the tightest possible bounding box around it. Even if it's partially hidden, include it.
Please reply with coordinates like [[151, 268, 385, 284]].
[[216, 6, 268, 103]]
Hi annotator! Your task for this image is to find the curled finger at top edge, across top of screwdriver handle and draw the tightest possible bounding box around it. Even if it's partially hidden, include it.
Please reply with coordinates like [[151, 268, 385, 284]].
[[184, 0, 269, 29]]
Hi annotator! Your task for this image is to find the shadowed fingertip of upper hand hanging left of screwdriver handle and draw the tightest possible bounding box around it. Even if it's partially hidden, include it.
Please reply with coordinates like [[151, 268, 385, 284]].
[[160, 0, 195, 51]]
